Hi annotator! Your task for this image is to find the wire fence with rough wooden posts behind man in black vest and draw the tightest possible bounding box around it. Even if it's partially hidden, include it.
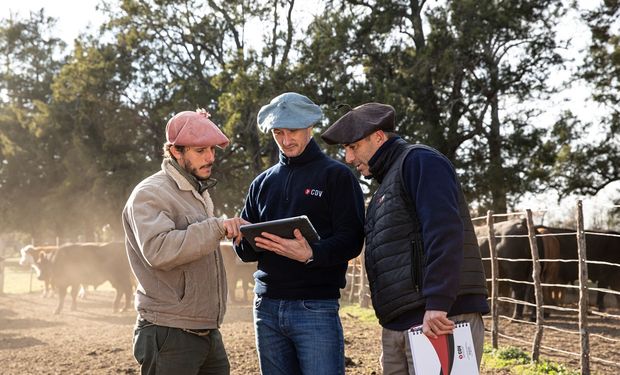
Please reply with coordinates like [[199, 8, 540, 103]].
[[343, 201, 620, 374]]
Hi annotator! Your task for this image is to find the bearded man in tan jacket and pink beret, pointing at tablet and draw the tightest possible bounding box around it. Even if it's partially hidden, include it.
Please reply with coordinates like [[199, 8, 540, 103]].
[[123, 110, 245, 374]]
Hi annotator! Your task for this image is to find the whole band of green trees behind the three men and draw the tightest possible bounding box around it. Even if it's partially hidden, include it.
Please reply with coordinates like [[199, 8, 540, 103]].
[[0, 0, 620, 241]]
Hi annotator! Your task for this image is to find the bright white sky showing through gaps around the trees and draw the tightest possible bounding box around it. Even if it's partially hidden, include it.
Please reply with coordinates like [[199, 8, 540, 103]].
[[0, 0, 620, 226]]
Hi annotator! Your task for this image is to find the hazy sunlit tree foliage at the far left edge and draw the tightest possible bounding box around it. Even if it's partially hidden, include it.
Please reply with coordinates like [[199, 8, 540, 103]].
[[0, 11, 70, 242]]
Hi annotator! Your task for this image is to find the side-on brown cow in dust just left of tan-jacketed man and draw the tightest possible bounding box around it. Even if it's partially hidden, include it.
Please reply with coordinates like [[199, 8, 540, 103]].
[[37, 242, 133, 314]]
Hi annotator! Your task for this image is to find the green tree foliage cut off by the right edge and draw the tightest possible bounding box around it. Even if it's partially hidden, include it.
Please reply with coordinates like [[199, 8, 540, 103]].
[[554, 1, 620, 200]]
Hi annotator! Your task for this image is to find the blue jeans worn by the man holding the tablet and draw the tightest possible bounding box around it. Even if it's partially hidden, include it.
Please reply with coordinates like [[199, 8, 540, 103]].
[[254, 296, 344, 375]]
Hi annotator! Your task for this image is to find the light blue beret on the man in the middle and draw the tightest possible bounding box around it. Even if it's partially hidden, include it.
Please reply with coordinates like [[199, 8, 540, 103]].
[[256, 92, 323, 133]]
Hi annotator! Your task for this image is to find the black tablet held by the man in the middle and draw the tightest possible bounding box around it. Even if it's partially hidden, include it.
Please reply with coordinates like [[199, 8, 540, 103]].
[[239, 215, 321, 251]]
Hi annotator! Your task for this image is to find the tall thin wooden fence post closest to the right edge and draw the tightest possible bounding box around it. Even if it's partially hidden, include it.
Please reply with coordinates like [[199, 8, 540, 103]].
[[577, 200, 590, 375]]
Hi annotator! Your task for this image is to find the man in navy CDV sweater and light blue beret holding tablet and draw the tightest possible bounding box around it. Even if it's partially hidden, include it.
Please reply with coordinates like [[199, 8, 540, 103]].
[[235, 92, 364, 375]]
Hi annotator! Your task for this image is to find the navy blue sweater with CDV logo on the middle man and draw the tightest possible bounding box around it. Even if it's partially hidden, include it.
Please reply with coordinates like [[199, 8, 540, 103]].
[[235, 140, 364, 299]]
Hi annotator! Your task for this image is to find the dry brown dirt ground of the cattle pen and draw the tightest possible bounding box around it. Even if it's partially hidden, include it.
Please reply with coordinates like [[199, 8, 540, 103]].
[[0, 291, 620, 375]]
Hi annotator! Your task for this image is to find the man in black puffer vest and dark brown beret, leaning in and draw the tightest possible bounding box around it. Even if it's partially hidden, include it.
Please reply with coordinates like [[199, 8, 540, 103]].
[[321, 103, 489, 375]]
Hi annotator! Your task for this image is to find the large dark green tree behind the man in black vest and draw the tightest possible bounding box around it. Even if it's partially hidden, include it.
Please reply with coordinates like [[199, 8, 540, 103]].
[[302, 0, 565, 216]]
